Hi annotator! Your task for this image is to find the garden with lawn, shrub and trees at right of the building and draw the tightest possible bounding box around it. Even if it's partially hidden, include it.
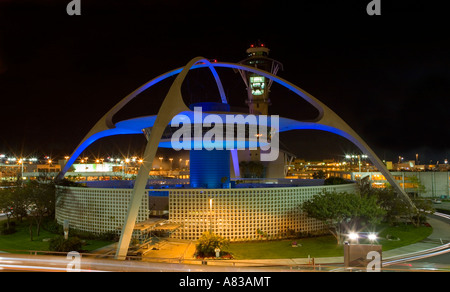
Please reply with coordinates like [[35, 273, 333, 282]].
[[193, 181, 434, 259]]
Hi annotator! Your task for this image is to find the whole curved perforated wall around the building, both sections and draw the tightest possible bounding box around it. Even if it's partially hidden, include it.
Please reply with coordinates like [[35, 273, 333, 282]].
[[56, 183, 356, 241]]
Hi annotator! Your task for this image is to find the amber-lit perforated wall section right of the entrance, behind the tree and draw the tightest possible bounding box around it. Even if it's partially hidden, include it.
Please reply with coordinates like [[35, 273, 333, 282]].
[[169, 184, 356, 241]]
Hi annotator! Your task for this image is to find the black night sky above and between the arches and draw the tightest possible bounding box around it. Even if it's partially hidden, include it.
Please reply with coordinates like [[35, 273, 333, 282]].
[[0, 0, 450, 161]]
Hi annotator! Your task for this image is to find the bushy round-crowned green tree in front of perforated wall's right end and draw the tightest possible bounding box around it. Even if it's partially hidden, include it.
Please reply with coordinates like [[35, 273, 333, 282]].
[[301, 192, 385, 244]]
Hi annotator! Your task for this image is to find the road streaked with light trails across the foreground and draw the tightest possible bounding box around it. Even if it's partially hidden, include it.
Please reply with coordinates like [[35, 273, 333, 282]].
[[0, 208, 450, 272]]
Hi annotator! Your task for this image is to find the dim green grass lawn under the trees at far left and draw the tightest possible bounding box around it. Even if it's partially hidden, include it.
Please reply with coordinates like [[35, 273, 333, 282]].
[[0, 220, 112, 253]]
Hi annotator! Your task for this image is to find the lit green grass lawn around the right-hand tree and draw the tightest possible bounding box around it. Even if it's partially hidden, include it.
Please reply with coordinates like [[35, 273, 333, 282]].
[[229, 225, 433, 259]]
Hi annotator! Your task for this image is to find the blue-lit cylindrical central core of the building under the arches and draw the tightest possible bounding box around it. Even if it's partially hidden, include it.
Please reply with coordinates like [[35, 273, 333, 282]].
[[189, 102, 230, 189]]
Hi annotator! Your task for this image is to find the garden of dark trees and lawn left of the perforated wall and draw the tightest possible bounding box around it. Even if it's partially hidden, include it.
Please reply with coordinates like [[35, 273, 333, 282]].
[[0, 179, 114, 253]]
